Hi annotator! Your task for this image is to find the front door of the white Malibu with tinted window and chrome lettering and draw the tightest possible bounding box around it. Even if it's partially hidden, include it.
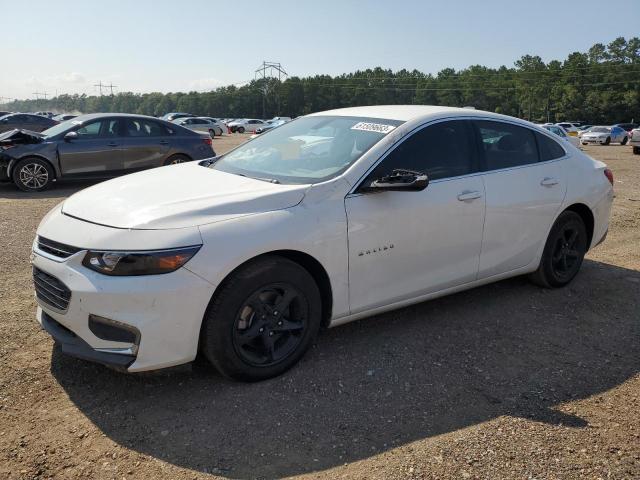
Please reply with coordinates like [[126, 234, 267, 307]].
[[345, 120, 485, 313]]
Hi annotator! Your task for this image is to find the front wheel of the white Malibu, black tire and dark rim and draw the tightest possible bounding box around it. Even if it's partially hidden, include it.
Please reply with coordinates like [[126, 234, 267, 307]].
[[200, 255, 322, 382]]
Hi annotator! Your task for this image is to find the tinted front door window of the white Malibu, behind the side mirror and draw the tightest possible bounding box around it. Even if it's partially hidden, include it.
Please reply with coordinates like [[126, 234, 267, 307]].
[[363, 120, 478, 185]]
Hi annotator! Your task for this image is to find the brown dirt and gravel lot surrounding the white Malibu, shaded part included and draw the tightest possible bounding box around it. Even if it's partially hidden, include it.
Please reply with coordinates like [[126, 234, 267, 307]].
[[0, 137, 640, 479]]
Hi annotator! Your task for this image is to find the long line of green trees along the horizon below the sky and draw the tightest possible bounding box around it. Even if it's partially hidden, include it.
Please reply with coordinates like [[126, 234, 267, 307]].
[[2, 37, 640, 123]]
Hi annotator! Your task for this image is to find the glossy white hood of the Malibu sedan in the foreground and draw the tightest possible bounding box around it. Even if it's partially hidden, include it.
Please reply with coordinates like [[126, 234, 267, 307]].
[[62, 162, 308, 230]]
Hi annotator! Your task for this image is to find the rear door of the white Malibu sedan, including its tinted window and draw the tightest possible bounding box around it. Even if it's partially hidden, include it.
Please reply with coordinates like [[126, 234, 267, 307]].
[[474, 121, 567, 278]]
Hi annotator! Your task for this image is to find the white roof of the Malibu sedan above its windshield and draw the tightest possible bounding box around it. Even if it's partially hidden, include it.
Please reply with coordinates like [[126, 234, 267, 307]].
[[309, 105, 513, 122]]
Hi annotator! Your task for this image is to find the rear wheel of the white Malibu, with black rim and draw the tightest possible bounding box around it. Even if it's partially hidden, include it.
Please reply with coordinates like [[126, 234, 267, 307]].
[[530, 211, 588, 288]]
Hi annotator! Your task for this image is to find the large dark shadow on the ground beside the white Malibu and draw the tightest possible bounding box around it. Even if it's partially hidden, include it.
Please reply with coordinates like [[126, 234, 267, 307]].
[[51, 261, 640, 478]]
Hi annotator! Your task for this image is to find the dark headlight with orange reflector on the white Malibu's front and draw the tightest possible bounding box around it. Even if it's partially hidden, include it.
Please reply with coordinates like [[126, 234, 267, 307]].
[[82, 245, 201, 275]]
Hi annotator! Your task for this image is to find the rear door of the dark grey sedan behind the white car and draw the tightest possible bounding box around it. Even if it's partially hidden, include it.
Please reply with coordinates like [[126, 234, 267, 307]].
[[122, 118, 171, 170]]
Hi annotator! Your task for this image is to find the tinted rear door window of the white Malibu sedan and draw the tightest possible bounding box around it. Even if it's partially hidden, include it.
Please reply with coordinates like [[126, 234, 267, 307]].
[[475, 121, 538, 170]]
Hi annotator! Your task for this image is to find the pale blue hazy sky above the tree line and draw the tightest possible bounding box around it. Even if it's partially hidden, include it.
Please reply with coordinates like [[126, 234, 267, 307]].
[[0, 0, 640, 103]]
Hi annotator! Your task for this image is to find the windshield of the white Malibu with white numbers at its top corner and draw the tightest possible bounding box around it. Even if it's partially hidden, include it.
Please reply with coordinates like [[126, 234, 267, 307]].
[[211, 116, 402, 184]]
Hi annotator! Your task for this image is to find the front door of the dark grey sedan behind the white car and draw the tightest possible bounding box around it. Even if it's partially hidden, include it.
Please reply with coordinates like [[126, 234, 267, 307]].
[[58, 118, 123, 177]]
